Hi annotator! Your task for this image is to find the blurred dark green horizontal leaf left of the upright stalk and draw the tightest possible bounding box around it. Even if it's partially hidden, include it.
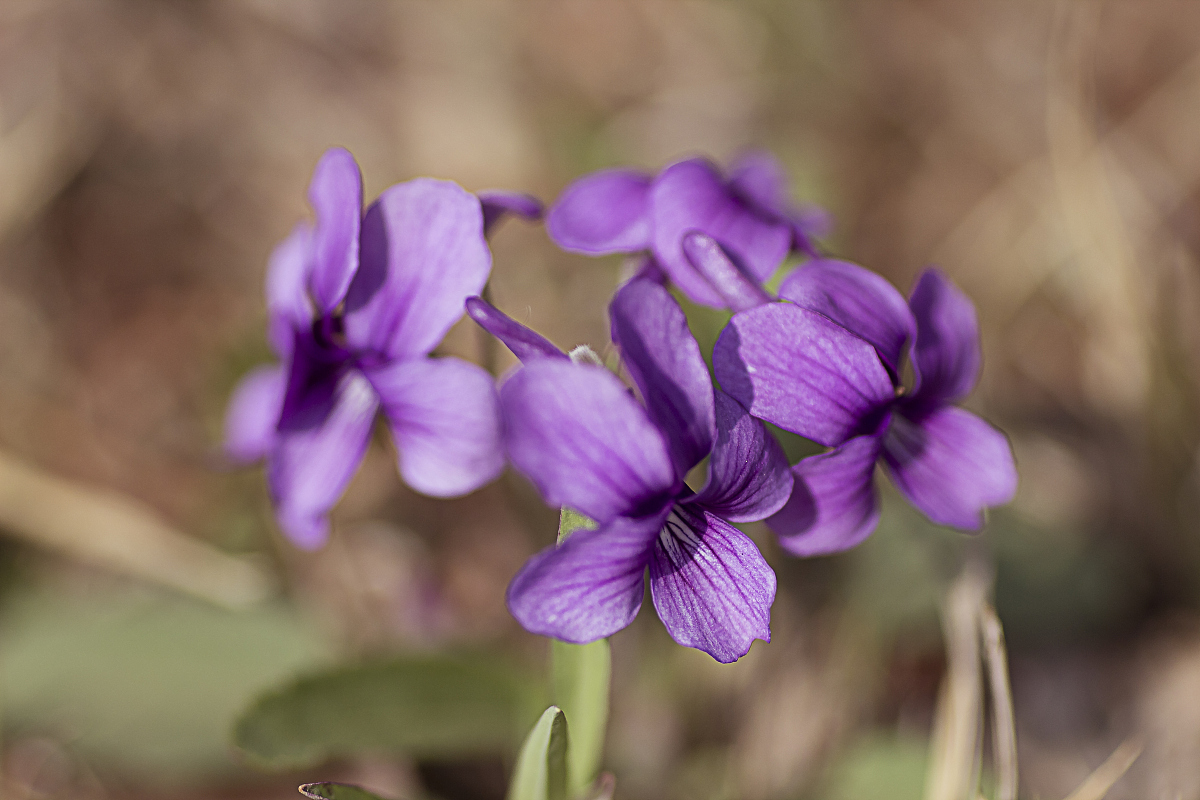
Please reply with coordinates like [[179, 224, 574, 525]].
[[234, 652, 545, 768]]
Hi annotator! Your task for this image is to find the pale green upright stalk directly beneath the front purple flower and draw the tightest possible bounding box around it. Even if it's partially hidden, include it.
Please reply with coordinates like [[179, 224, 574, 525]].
[[550, 639, 612, 798]]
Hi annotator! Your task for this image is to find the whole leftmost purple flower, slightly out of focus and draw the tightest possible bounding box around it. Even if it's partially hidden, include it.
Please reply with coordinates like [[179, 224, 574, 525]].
[[226, 149, 504, 548]]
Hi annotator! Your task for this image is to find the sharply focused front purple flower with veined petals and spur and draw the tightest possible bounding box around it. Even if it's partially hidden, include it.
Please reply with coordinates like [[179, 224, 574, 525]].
[[468, 279, 791, 663]]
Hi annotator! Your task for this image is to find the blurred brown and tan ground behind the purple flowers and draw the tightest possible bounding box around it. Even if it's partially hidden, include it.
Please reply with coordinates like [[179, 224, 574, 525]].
[[0, 0, 1200, 800]]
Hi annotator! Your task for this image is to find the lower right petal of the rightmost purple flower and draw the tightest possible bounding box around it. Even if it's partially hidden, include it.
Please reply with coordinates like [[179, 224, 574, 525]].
[[883, 408, 1016, 530]]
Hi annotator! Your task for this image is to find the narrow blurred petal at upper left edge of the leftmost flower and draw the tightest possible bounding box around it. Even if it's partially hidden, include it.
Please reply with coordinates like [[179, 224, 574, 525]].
[[266, 222, 312, 361]]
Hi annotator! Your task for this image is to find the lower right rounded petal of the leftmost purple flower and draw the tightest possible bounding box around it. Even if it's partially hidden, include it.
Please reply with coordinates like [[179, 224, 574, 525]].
[[366, 359, 504, 498]]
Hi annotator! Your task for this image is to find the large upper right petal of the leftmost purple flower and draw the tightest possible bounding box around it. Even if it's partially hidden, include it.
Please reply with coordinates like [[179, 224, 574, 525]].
[[346, 178, 492, 359]]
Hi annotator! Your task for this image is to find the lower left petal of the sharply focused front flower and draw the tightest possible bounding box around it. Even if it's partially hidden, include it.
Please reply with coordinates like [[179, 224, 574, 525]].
[[508, 512, 666, 644]]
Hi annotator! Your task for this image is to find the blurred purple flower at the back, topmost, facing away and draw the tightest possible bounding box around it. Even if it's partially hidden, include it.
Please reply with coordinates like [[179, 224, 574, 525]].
[[546, 152, 829, 308]]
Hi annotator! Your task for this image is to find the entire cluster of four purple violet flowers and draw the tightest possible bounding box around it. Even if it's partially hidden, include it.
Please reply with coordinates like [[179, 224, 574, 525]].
[[227, 150, 1016, 662]]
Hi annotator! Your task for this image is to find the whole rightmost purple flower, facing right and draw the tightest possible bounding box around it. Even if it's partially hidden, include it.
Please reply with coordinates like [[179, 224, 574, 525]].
[[713, 260, 1016, 555]]
